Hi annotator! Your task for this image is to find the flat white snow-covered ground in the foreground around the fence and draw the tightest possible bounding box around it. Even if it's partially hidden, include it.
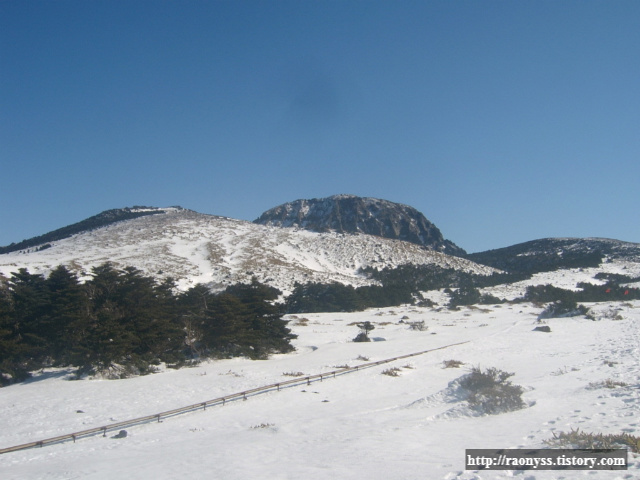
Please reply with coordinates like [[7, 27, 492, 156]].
[[0, 301, 640, 480]]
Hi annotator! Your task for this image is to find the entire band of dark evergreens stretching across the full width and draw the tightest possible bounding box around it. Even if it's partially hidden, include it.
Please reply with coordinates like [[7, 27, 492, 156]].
[[0, 263, 640, 385]]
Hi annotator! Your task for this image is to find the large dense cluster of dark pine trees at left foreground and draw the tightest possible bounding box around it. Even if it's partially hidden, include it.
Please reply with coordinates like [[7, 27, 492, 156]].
[[0, 263, 295, 384]]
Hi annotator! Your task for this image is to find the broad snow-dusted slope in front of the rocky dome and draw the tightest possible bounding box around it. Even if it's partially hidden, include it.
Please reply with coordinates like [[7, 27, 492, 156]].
[[0, 208, 493, 291]]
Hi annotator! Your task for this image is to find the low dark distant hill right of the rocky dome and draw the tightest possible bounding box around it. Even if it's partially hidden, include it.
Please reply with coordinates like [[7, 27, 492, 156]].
[[465, 238, 640, 274]]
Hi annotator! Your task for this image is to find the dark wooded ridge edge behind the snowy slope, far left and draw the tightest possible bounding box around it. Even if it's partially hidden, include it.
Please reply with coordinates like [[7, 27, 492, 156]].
[[0, 206, 179, 254]]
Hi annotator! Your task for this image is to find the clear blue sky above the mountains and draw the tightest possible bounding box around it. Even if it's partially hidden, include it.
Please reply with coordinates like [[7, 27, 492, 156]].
[[0, 0, 640, 252]]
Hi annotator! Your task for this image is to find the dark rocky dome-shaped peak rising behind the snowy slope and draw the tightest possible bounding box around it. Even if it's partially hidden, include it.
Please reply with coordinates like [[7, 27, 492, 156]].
[[254, 195, 465, 255]]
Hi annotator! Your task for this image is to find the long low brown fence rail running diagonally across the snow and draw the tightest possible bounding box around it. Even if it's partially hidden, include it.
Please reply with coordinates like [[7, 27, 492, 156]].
[[0, 341, 469, 454]]
